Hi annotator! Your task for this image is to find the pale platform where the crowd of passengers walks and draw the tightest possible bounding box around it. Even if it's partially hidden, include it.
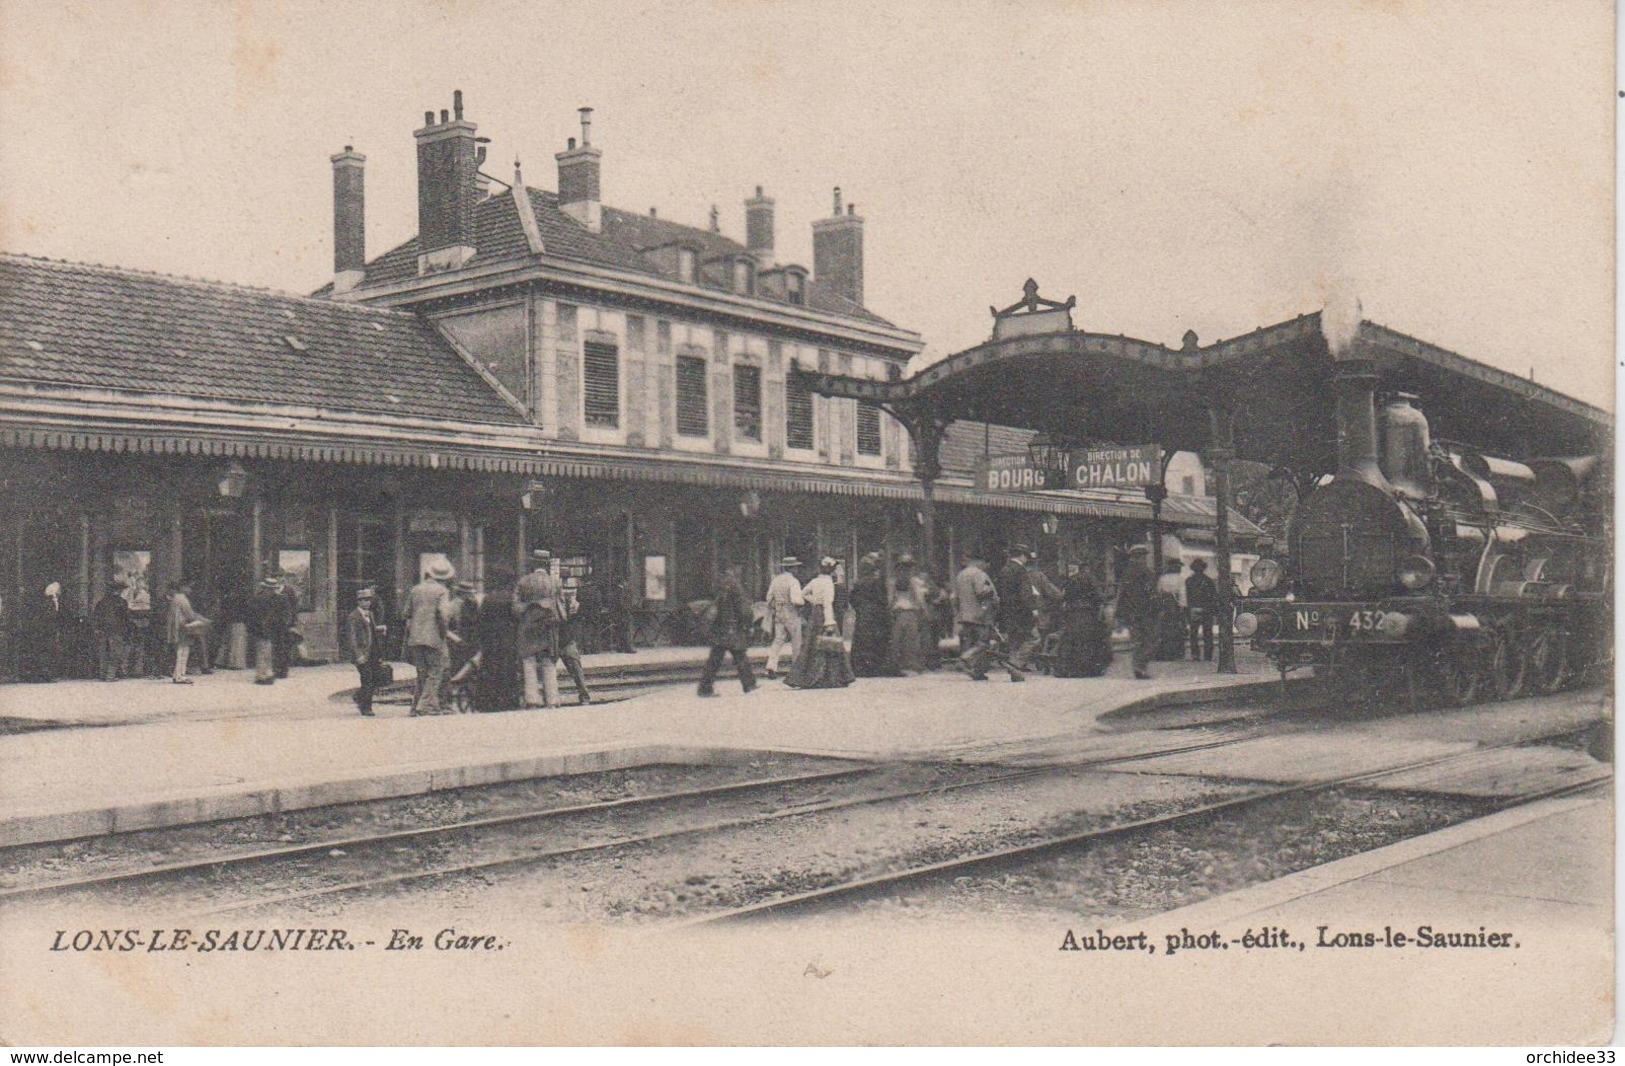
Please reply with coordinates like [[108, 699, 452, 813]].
[[0, 648, 1279, 845]]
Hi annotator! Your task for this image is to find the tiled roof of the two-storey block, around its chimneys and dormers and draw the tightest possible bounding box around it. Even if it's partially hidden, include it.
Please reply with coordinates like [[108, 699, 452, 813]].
[[331, 189, 892, 327]]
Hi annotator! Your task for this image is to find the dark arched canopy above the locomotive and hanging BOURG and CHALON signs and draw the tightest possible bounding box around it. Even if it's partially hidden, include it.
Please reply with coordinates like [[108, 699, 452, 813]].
[[793, 281, 1612, 476]]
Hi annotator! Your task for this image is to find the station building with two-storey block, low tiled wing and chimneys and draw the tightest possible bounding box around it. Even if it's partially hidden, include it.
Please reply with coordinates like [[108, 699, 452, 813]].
[[0, 96, 1241, 671]]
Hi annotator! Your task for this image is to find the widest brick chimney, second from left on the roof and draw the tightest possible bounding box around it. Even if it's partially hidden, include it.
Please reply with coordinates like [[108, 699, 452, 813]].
[[413, 89, 483, 275]]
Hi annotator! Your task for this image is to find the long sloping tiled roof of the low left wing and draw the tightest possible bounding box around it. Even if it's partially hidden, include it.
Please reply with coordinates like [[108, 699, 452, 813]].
[[0, 255, 523, 424]]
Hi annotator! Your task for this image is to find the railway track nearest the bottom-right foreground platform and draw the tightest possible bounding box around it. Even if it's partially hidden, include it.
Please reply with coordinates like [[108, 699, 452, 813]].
[[668, 726, 1609, 928]]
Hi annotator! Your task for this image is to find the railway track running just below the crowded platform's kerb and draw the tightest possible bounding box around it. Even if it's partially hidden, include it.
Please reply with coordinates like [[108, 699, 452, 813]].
[[0, 735, 1251, 913]]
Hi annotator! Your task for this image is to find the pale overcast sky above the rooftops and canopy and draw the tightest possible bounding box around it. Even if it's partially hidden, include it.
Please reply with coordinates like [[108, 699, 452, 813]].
[[0, 0, 1614, 408]]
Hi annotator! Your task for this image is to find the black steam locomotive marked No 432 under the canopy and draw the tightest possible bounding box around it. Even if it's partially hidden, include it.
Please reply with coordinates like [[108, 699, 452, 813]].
[[1235, 362, 1612, 705]]
